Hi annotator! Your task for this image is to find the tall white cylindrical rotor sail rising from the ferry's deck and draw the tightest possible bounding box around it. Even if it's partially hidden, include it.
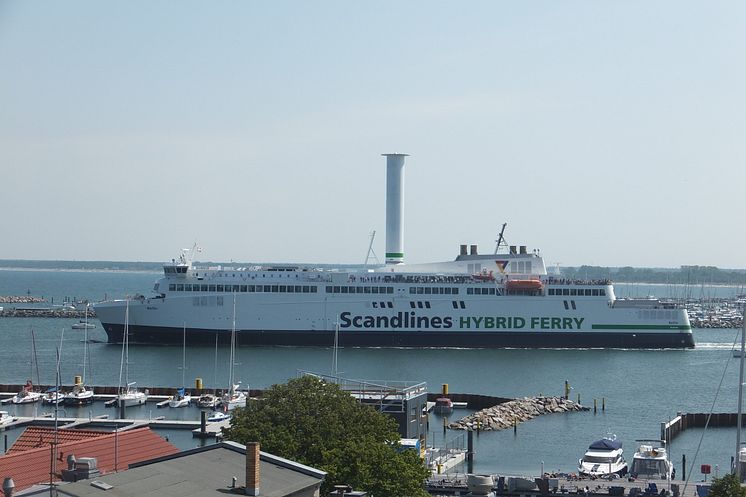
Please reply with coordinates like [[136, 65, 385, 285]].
[[383, 154, 408, 264]]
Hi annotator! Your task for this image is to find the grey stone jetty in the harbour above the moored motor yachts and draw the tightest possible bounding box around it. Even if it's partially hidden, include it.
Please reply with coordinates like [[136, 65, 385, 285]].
[[448, 397, 590, 431]]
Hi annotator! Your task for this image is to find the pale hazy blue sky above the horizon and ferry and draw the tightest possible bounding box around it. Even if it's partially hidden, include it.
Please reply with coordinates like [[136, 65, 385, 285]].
[[0, 0, 746, 268]]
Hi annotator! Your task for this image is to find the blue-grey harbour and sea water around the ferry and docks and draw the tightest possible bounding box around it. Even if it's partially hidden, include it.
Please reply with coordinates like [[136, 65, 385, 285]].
[[0, 270, 740, 478]]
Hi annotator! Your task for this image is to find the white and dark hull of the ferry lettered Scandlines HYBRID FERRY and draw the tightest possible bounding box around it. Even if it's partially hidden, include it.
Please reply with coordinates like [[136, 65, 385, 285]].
[[95, 273, 694, 348]]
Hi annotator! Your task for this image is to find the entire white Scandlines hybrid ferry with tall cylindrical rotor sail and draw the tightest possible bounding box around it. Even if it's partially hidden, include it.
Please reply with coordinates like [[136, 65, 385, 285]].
[[94, 154, 694, 348]]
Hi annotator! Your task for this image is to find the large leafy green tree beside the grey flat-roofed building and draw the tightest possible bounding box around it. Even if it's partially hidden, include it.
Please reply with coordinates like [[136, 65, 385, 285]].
[[224, 376, 428, 497]]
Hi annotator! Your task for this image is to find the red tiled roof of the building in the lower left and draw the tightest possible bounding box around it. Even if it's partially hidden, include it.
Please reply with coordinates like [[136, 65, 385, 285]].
[[0, 427, 179, 492]]
